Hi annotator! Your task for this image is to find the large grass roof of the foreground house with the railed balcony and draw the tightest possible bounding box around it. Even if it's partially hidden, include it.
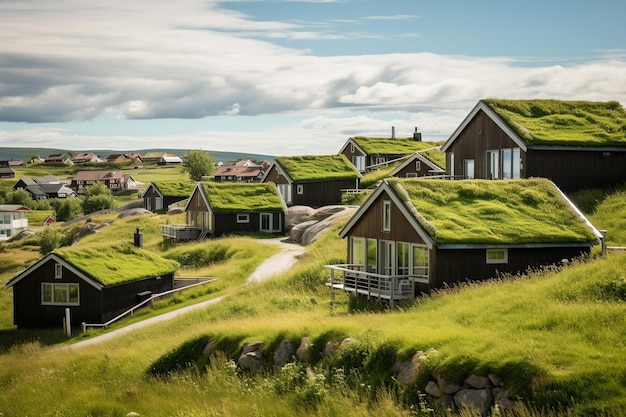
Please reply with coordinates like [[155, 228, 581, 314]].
[[388, 178, 597, 245]]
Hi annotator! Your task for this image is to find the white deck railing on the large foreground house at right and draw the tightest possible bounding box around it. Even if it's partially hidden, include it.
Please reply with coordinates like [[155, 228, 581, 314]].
[[326, 264, 415, 304]]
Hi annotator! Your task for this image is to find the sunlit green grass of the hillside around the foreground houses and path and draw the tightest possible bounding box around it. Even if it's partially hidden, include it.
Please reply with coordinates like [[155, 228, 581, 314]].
[[0, 164, 626, 416]]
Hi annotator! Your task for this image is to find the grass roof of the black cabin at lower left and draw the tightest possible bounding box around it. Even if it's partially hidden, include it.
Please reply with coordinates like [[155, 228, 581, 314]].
[[54, 243, 179, 285]]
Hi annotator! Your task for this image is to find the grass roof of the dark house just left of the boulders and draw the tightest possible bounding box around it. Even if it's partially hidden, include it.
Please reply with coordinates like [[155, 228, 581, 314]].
[[202, 182, 284, 213]]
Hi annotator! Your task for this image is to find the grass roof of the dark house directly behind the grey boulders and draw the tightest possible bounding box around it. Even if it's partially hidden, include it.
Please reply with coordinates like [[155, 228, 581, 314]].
[[276, 155, 361, 182]]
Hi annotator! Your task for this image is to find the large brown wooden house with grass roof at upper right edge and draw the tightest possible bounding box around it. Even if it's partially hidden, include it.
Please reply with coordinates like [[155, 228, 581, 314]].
[[442, 99, 626, 191]]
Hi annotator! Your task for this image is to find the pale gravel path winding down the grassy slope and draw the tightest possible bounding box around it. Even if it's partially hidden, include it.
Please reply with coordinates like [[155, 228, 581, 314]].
[[63, 239, 304, 350]]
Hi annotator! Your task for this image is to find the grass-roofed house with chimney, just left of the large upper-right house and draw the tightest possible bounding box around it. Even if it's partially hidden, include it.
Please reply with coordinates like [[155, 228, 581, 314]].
[[339, 131, 443, 173]]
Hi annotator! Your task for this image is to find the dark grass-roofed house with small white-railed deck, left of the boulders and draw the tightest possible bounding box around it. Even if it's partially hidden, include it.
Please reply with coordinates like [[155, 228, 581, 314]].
[[161, 181, 286, 240]]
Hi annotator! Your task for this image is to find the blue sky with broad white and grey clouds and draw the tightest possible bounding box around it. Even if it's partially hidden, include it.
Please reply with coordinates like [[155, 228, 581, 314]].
[[0, 0, 626, 156]]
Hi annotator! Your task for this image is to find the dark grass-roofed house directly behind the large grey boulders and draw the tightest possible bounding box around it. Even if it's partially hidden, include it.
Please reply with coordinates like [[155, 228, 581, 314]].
[[262, 155, 361, 207]]
